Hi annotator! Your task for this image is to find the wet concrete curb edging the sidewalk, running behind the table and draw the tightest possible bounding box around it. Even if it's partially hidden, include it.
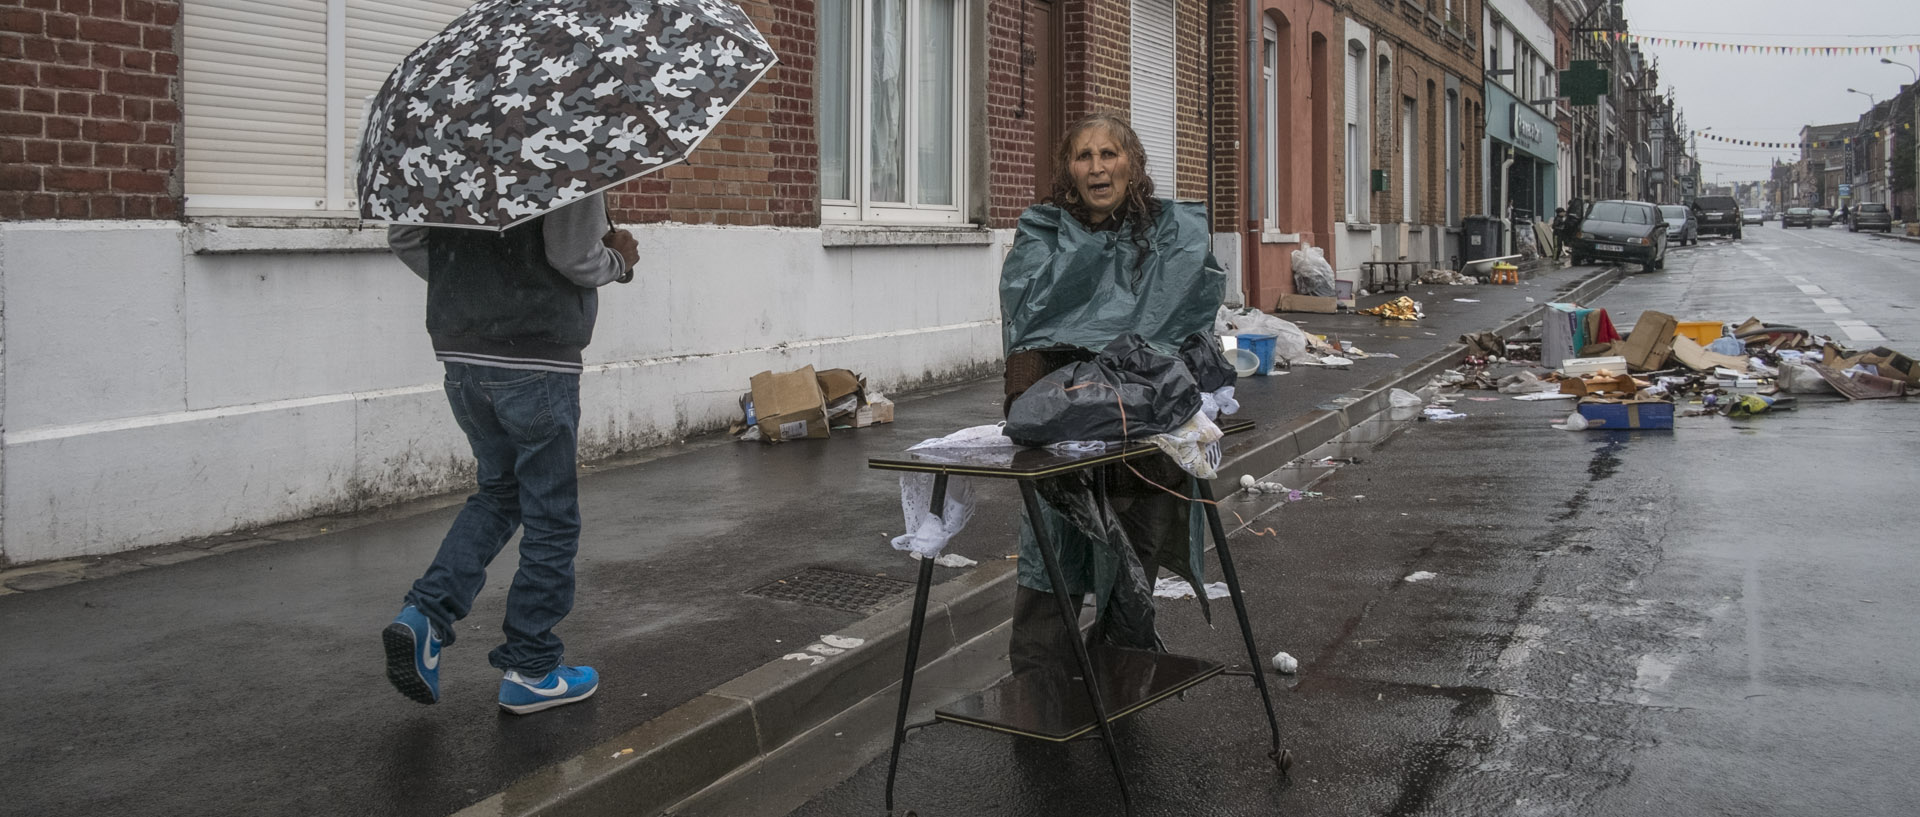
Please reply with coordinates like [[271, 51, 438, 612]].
[[455, 268, 1622, 817]]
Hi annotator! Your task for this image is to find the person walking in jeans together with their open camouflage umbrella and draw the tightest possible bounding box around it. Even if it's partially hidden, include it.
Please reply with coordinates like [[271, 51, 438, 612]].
[[355, 0, 776, 713]]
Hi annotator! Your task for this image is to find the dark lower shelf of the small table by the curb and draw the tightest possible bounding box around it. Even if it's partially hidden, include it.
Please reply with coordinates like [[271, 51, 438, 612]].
[[933, 646, 1227, 742]]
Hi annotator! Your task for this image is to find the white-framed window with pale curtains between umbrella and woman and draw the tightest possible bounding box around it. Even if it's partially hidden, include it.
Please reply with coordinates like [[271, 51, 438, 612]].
[[816, 0, 968, 224]]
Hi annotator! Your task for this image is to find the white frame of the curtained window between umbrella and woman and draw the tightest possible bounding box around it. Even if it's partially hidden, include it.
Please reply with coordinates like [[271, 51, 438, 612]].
[[818, 0, 972, 224]]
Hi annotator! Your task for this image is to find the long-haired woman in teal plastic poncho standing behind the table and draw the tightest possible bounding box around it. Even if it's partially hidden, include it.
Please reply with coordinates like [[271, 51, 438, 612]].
[[1000, 113, 1225, 673]]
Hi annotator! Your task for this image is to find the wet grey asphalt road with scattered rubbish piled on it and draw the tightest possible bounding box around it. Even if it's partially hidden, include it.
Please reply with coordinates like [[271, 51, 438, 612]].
[[771, 224, 1920, 817]]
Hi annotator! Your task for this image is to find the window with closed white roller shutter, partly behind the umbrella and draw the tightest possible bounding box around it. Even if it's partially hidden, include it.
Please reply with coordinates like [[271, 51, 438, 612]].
[[180, 0, 468, 215]]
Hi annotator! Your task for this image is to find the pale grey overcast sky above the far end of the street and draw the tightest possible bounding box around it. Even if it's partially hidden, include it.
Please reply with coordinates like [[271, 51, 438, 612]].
[[1624, 0, 1920, 182]]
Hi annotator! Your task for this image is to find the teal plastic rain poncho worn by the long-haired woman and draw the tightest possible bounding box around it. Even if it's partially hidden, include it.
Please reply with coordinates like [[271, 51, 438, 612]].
[[1000, 201, 1227, 648]]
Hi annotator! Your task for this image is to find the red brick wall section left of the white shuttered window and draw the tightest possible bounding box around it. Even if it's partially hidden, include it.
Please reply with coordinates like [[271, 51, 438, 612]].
[[0, 0, 180, 221]]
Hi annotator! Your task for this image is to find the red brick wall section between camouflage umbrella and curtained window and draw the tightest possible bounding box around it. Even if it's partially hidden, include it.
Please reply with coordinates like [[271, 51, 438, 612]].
[[609, 0, 802, 226]]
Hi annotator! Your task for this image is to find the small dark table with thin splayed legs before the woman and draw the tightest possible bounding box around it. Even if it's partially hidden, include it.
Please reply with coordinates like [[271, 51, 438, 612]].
[[868, 422, 1292, 815]]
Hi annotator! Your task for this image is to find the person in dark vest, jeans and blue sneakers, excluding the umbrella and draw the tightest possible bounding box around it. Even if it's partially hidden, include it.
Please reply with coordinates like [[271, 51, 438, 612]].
[[382, 194, 639, 715]]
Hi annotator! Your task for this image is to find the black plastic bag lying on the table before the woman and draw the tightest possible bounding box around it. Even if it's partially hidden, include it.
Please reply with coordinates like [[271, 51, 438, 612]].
[[1006, 334, 1200, 445]]
